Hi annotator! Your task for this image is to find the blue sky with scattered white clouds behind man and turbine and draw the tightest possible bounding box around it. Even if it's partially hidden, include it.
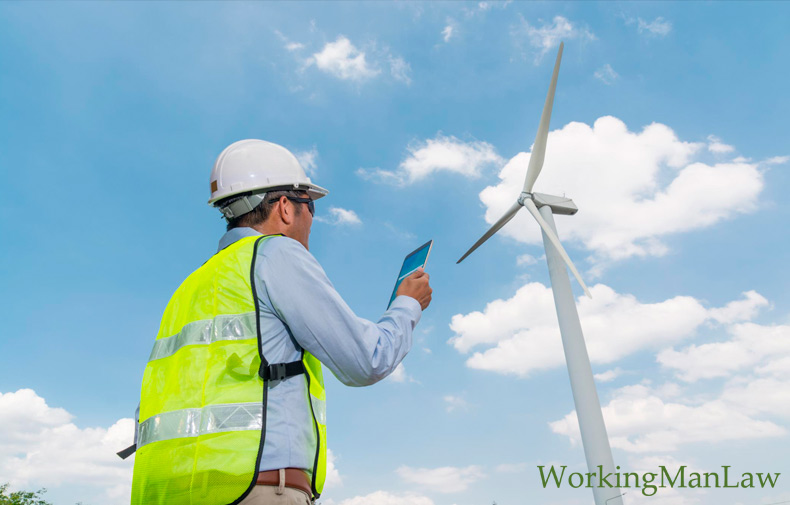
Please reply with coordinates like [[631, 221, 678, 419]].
[[0, 2, 790, 505]]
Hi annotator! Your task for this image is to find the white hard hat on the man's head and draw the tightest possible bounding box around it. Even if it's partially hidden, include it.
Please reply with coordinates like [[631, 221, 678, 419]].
[[208, 139, 329, 219]]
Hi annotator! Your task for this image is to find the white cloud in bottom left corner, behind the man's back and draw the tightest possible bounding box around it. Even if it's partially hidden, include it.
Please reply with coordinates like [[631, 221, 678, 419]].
[[0, 389, 134, 504]]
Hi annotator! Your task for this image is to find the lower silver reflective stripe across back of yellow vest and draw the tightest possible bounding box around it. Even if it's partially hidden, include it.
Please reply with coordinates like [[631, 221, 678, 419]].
[[137, 403, 263, 449]]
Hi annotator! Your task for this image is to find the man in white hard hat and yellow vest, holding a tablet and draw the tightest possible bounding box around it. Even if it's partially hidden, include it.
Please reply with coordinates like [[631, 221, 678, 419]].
[[132, 140, 432, 505]]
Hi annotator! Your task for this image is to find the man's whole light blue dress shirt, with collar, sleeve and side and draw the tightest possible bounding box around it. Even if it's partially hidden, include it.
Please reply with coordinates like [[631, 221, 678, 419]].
[[219, 228, 422, 471]]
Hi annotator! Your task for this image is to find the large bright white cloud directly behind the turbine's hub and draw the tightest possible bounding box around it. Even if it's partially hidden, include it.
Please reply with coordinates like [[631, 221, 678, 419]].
[[480, 116, 763, 265]]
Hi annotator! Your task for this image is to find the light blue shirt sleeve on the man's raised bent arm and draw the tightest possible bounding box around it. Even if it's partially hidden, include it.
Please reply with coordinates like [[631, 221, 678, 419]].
[[255, 237, 422, 386]]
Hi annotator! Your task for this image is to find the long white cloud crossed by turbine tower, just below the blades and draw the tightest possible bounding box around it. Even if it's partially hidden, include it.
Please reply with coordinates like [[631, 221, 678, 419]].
[[448, 283, 759, 377]]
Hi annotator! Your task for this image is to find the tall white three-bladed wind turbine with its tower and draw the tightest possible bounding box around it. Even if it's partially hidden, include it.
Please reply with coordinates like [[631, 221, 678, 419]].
[[457, 43, 623, 505]]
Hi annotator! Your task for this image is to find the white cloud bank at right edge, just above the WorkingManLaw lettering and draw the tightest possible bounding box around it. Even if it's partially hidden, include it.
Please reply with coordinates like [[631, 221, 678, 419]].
[[550, 310, 790, 453]]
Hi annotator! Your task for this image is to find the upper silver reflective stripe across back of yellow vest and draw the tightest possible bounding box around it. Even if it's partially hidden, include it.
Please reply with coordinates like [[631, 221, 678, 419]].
[[148, 312, 258, 361]]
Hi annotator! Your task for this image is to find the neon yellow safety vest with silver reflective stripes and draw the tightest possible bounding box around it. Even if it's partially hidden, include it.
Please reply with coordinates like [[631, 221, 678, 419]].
[[132, 236, 326, 505]]
